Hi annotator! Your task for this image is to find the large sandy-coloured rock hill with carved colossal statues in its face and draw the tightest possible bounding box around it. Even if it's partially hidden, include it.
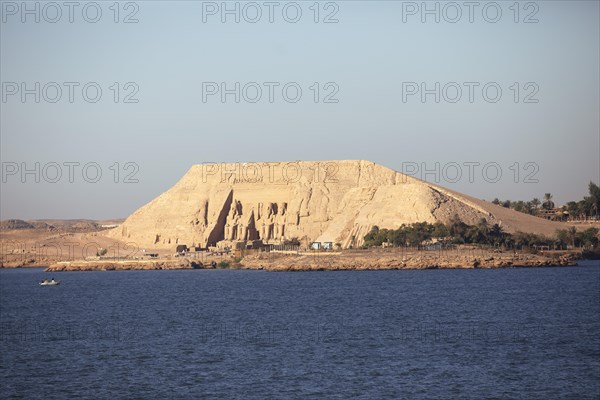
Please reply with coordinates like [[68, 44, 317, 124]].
[[106, 161, 555, 248]]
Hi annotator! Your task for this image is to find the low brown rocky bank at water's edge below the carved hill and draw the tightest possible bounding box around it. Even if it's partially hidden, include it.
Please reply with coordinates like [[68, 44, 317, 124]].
[[34, 251, 577, 272]]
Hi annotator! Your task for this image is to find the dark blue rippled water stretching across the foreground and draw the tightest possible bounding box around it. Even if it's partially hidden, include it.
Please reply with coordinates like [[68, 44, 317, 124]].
[[0, 263, 600, 399]]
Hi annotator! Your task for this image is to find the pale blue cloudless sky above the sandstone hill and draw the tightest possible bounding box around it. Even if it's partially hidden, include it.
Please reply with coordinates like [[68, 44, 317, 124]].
[[0, 1, 600, 219]]
